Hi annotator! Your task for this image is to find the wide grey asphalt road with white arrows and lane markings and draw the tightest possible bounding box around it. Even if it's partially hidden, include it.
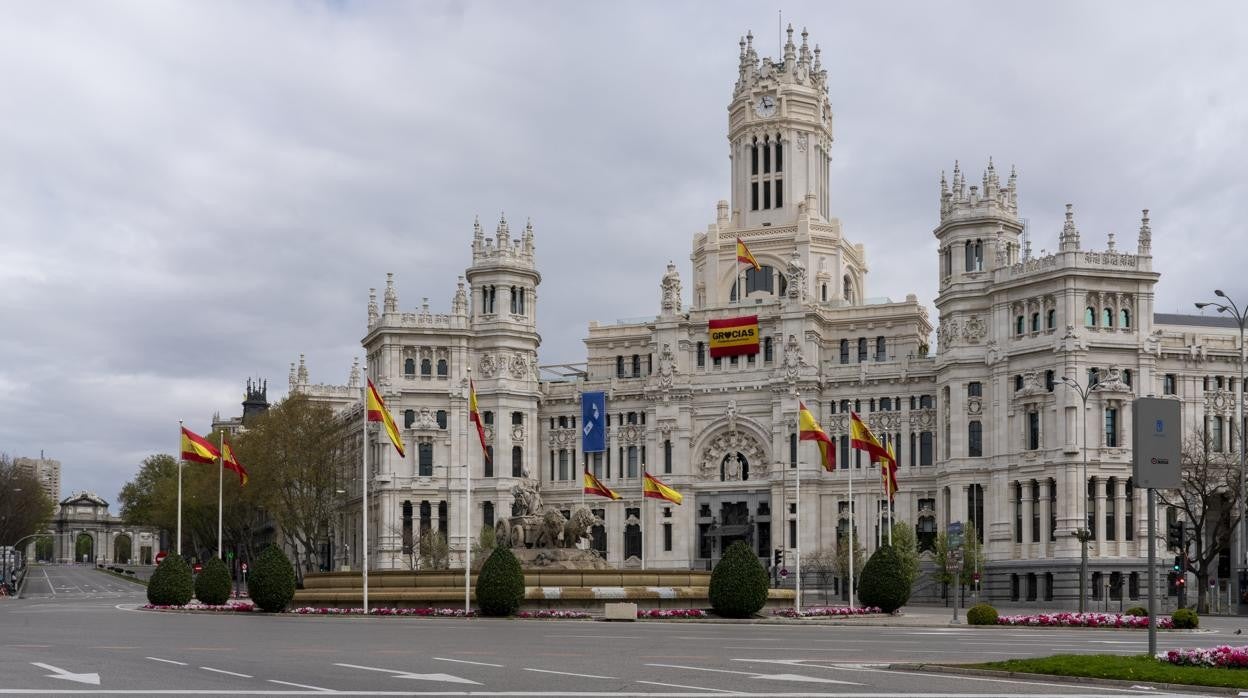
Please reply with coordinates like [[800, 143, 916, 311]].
[[0, 567, 1248, 698]]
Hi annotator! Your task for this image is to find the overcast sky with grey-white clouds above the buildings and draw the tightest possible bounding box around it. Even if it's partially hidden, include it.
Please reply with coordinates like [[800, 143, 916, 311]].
[[0, 0, 1248, 501]]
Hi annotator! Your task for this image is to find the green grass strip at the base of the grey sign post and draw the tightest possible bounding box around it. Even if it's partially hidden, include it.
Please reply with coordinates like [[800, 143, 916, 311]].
[[963, 654, 1248, 688]]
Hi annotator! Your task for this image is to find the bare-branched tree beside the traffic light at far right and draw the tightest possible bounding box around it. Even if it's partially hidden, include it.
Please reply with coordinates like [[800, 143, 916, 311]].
[[1157, 429, 1239, 613]]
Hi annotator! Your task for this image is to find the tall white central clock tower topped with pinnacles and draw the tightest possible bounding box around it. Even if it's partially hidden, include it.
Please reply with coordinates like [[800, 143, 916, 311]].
[[728, 25, 832, 227]]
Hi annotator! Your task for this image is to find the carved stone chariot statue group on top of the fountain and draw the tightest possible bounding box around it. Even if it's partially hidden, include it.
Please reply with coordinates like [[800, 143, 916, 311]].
[[494, 473, 609, 569]]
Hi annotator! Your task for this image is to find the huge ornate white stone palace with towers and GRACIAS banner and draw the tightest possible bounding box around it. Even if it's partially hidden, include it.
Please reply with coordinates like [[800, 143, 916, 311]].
[[299, 29, 1238, 606]]
